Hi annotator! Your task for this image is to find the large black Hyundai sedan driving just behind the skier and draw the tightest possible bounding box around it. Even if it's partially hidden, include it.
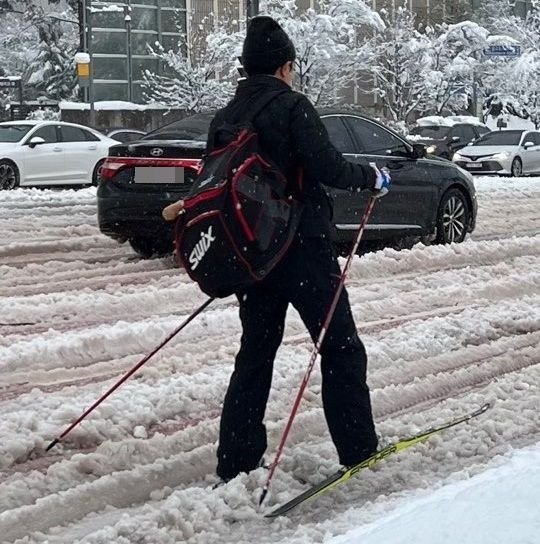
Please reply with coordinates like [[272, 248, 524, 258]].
[[98, 110, 477, 257]]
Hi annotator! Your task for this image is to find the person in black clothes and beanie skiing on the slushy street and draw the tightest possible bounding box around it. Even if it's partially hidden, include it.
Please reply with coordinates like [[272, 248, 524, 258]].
[[163, 16, 390, 481]]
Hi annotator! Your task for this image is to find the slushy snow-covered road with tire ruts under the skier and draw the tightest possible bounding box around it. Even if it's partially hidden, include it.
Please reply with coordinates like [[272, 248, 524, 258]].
[[0, 177, 540, 544]]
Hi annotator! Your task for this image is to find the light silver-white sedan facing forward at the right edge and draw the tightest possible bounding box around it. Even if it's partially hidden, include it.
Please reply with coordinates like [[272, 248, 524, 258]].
[[453, 130, 540, 177]]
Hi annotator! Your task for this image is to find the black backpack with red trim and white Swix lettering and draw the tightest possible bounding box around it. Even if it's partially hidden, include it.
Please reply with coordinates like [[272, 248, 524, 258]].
[[176, 91, 302, 297]]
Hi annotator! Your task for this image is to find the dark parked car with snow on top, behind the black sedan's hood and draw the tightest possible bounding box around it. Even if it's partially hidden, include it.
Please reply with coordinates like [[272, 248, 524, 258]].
[[407, 115, 489, 159]]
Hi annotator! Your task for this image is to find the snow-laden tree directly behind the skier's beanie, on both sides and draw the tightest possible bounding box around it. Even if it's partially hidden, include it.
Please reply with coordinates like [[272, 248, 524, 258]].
[[144, 0, 383, 111]]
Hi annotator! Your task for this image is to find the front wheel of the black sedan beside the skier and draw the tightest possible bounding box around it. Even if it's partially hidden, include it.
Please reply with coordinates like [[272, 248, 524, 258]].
[[436, 189, 471, 244]]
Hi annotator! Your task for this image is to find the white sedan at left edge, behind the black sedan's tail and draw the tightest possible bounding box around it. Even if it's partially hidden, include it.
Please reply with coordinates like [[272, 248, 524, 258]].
[[0, 121, 118, 190]]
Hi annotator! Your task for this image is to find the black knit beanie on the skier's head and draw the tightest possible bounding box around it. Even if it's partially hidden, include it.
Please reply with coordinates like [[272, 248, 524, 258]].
[[242, 16, 296, 76]]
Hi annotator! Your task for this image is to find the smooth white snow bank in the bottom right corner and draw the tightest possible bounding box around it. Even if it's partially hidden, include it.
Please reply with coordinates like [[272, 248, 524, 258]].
[[329, 443, 540, 544]]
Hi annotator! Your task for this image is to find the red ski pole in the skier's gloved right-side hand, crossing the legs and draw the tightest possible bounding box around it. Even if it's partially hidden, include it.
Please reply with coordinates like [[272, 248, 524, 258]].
[[259, 197, 376, 505]]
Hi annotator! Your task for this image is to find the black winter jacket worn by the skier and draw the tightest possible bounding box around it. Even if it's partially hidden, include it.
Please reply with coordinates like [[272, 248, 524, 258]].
[[207, 75, 375, 237]]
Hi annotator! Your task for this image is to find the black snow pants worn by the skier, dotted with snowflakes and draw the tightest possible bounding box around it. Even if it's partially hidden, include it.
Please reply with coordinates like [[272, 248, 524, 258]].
[[217, 238, 377, 479]]
